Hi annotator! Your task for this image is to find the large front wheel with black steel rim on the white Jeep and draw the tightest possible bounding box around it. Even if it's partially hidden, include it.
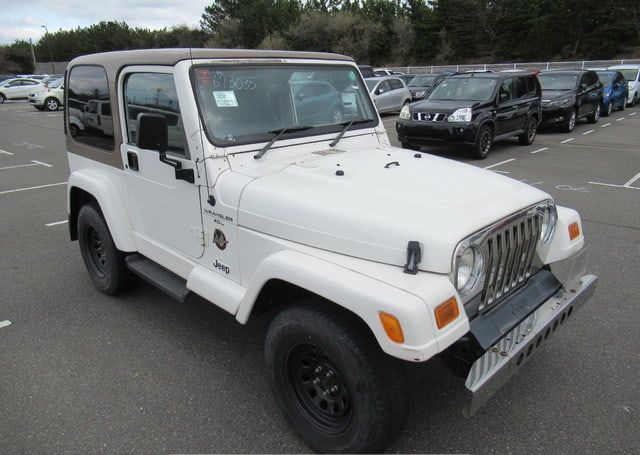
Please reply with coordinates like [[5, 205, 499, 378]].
[[265, 302, 408, 453]]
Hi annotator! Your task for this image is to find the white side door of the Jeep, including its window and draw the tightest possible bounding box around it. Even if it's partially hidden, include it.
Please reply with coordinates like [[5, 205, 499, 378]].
[[119, 67, 204, 258]]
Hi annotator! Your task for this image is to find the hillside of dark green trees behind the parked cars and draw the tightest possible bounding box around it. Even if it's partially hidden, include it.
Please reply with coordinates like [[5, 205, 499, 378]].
[[0, 0, 640, 73]]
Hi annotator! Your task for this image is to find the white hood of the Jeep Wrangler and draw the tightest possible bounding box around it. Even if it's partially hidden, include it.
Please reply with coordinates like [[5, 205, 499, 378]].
[[238, 146, 549, 273]]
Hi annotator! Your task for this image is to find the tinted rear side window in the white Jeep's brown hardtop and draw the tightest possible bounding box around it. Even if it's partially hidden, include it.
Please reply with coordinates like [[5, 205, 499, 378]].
[[67, 65, 115, 151]]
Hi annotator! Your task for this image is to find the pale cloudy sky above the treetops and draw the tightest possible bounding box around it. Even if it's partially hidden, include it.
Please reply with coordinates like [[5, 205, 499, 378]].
[[0, 0, 212, 44]]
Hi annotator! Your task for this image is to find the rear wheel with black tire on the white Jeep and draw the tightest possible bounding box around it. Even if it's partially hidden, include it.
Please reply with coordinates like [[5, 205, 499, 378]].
[[78, 204, 135, 295]]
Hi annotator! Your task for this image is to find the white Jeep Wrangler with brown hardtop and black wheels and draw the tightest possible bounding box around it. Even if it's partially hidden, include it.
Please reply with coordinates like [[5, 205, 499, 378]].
[[64, 49, 597, 452]]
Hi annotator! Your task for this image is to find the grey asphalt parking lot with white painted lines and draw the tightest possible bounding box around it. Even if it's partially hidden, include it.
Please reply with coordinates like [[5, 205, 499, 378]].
[[0, 103, 640, 454]]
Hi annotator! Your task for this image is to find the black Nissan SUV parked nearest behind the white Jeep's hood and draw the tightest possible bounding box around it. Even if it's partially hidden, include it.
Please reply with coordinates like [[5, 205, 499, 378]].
[[396, 73, 542, 159]]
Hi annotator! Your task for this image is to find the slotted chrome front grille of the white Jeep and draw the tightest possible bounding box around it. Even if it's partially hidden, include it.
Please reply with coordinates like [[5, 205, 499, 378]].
[[479, 210, 541, 311]]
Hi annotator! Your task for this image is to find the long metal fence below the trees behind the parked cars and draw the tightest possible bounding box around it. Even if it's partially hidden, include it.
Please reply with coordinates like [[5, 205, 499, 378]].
[[389, 59, 640, 74]]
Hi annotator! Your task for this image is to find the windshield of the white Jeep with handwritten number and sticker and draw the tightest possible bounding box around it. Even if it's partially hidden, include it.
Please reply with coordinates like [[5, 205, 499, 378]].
[[192, 64, 378, 146]]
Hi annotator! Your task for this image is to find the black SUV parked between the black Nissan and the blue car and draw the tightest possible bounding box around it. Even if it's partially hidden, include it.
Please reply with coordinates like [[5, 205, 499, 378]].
[[538, 70, 604, 133]]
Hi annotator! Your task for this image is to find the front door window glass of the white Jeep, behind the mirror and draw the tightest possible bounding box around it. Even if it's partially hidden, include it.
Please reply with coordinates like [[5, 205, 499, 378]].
[[124, 73, 186, 155]]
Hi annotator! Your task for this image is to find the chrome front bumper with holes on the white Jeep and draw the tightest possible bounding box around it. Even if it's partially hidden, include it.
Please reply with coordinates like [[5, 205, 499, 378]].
[[463, 275, 598, 417]]
